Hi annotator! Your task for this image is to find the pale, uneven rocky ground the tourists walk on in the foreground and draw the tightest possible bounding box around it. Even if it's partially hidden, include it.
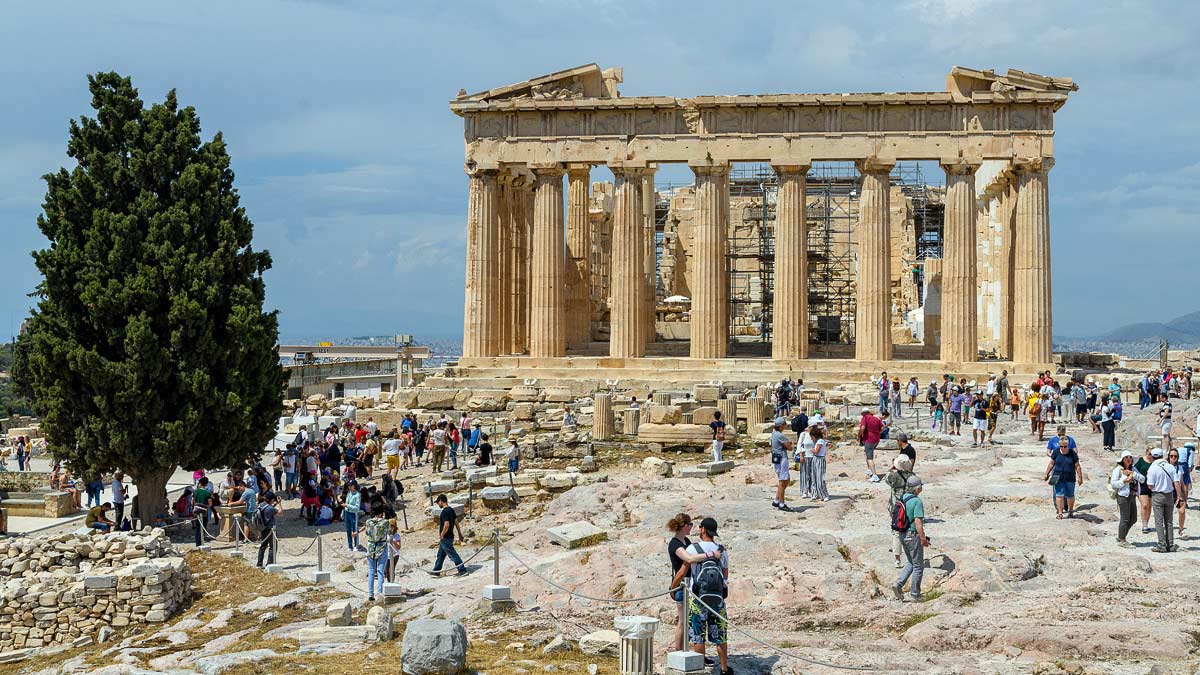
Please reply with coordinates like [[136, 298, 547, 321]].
[[9, 393, 1200, 675]]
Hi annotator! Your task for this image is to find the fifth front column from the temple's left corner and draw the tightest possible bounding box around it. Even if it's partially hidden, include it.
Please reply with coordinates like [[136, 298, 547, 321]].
[[770, 165, 809, 359]]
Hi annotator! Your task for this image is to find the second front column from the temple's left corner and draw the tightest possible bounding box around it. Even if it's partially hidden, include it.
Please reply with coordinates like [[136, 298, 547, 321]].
[[529, 166, 566, 358]]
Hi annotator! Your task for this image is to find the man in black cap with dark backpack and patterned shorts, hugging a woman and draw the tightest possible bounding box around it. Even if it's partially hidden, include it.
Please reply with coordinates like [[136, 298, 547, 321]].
[[671, 514, 724, 675]]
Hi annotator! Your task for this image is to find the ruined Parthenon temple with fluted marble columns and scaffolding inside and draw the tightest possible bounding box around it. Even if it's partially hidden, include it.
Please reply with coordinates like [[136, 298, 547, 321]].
[[450, 64, 1078, 389]]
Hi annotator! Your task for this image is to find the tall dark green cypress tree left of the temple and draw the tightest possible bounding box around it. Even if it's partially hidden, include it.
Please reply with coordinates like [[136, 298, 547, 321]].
[[13, 72, 284, 522]]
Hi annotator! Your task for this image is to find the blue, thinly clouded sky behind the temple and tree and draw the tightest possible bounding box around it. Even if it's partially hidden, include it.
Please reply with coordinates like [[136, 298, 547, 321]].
[[0, 0, 1200, 336]]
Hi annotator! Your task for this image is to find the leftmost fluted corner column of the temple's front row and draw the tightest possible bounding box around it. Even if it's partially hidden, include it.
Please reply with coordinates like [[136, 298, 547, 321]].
[[462, 169, 500, 358]]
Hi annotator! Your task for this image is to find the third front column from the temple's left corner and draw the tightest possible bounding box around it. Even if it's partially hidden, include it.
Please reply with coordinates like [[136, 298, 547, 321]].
[[608, 166, 648, 358]]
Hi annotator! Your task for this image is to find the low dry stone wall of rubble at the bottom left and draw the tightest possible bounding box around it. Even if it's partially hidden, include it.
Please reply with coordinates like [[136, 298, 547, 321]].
[[0, 530, 192, 651]]
